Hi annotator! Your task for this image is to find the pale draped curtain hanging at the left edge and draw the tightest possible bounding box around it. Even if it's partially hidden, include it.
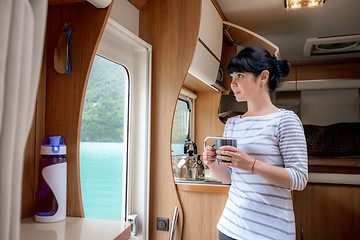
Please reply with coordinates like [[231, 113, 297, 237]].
[[0, 0, 48, 240]]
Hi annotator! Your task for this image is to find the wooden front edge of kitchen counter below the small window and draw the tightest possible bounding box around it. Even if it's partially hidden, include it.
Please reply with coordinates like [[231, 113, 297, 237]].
[[176, 183, 230, 194]]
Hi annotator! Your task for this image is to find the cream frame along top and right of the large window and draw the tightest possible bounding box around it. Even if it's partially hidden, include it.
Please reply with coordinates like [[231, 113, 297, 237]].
[[93, 18, 152, 239]]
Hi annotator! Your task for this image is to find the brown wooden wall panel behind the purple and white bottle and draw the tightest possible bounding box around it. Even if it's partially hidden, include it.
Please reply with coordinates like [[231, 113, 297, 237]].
[[21, 2, 111, 218]]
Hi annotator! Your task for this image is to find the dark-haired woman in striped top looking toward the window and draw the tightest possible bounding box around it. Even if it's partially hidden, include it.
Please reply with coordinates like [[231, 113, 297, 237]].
[[203, 47, 308, 240]]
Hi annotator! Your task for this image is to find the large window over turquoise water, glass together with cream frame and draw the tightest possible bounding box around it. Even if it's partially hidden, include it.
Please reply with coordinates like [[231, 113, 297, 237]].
[[80, 18, 151, 239]]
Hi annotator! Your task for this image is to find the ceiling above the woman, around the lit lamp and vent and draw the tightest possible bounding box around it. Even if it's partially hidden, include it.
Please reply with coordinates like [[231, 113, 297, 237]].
[[216, 0, 360, 62]]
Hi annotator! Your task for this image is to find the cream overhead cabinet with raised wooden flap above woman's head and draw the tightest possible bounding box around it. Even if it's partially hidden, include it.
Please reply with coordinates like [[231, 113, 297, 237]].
[[184, 0, 279, 91]]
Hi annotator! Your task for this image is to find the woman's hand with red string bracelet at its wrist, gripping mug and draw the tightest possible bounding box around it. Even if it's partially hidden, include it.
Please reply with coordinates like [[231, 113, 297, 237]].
[[216, 146, 255, 172]]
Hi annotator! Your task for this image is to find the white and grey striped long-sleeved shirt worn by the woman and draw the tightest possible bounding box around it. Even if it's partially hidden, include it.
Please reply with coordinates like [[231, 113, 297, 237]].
[[217, 109, 308, 240]]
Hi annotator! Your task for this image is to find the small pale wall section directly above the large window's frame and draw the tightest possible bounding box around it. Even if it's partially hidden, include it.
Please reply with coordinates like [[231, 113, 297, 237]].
[[110, 0, 139, 36]]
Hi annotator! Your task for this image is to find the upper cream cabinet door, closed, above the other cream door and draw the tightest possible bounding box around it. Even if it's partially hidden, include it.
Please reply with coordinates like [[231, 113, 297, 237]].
[[199, 0, 223, 59]]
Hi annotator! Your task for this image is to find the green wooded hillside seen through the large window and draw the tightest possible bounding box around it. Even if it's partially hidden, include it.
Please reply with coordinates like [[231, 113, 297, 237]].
[[80, 55, 128, 142]]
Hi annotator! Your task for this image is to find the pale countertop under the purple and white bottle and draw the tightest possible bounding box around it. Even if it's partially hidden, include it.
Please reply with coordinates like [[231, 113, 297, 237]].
[[20, 217, 131, 240]]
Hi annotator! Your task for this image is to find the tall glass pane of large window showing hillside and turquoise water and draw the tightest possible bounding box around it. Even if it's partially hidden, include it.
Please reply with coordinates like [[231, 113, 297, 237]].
[[80, 55, 129, 220]]
